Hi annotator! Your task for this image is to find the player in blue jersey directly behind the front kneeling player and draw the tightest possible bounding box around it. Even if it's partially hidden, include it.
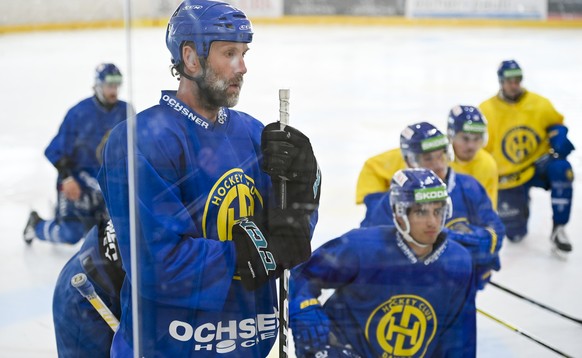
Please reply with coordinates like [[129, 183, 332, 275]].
[[362, 122, 505, 289]]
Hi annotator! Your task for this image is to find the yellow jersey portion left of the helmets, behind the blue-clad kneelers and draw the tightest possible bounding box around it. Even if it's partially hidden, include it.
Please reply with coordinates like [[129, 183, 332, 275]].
[[356, 148, 407, 204]]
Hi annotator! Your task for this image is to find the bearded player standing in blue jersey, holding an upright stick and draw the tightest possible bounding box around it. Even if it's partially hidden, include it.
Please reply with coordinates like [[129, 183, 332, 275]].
[[98, 0, 321, 358]]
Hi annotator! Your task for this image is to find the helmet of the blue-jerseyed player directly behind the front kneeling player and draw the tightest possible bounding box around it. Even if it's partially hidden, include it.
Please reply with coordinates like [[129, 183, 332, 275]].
[[400, 122, 452, 167]]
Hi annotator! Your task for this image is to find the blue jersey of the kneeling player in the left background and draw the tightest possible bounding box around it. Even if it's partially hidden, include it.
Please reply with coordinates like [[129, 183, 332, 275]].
[[45, 96, 127, 184]]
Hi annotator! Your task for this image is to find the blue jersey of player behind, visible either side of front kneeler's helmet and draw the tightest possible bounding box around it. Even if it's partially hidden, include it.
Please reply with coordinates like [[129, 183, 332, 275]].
[[361, 168, 505, 288]]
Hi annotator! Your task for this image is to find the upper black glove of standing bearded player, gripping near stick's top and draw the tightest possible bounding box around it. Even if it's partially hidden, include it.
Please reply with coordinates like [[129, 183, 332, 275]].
[[261, 122, 321, 213]]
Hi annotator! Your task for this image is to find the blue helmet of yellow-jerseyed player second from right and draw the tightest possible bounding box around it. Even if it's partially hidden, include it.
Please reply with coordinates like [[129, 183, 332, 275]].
[[447, 105, 487, 142]]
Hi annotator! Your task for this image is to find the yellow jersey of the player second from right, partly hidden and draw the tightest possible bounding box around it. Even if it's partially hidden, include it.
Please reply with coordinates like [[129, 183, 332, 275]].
[[450, 149, 499, 209]]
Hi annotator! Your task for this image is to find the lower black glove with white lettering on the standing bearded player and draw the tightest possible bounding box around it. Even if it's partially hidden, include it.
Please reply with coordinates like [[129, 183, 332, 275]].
[[232, 209, 311, 290]]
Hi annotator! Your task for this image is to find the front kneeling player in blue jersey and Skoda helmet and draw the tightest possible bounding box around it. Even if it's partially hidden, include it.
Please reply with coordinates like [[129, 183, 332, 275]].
[[289, 169, 476, 358]]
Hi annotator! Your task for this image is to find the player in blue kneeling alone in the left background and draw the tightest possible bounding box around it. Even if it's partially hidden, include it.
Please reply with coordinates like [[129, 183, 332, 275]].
[[24, 63, 128, 244]]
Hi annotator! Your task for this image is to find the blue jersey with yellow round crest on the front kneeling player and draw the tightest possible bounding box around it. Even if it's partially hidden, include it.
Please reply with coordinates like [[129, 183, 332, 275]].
[[289, 226, 476, 357]]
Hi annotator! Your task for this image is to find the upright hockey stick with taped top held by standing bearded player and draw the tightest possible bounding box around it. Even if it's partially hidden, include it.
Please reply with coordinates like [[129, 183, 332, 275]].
[[279, 89, 290, 358]]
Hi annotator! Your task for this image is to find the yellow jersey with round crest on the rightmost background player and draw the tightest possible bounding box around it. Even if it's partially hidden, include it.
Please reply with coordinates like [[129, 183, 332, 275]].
[[479, 91, 564, 189]]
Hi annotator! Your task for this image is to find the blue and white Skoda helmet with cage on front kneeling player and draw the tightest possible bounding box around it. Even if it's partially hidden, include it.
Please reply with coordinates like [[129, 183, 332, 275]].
[[390, 168, 453, 247]]
